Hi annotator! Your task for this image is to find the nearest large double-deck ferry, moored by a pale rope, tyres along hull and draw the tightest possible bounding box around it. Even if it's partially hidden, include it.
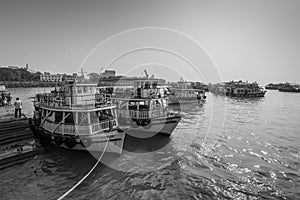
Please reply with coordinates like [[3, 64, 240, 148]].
[[30, 80, 125, 154]]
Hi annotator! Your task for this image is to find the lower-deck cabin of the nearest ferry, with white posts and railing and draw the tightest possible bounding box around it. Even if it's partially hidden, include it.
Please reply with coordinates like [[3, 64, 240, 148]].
[[36, 106, 118, 135]]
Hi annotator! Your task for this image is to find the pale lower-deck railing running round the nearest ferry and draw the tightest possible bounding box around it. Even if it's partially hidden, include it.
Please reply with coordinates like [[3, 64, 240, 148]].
[[43, 120, 117, 136]]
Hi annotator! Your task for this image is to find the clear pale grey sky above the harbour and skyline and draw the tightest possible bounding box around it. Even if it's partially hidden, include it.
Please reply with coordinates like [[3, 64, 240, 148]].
[[0, 0, 300, 84]]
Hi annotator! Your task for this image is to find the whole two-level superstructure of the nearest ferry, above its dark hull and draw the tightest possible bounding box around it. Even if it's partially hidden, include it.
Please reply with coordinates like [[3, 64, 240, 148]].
[[34, 79, 118, 135]]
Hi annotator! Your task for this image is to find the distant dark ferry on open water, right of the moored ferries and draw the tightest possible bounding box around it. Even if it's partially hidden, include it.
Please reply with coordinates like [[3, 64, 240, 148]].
[[210, 81, 266, 97]]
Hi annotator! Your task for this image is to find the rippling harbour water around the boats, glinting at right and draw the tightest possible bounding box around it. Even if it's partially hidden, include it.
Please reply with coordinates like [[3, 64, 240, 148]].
[[0, 89, 300, 199]]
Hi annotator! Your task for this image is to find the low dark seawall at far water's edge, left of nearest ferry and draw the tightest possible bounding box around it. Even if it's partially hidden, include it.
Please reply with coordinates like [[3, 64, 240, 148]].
[[0, 81, 63, 88]]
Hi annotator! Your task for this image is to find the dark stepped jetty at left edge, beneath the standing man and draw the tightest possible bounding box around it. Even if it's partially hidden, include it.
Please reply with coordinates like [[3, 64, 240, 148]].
[[0, 116, 44, 169]]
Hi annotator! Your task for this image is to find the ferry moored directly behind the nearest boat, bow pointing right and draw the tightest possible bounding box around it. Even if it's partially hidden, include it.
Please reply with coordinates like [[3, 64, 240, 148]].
[[104, 79, 181, 138]]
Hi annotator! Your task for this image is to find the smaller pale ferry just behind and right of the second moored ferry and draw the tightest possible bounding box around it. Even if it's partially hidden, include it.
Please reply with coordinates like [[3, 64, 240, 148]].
[[168, 81, 206, 104]]
